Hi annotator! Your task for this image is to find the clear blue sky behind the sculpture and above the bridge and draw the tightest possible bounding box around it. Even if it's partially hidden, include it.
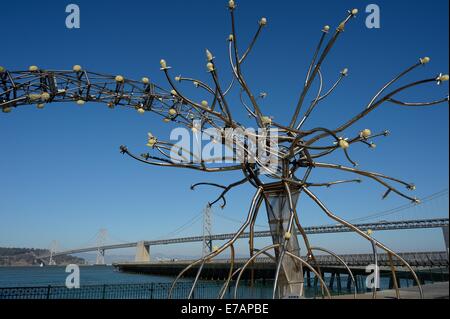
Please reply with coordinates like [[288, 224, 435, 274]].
[[0, 0, 449, 253]]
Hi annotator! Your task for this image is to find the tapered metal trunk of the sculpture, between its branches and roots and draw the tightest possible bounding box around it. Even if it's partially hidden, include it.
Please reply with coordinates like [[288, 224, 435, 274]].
[[266, 185, 304, 298]]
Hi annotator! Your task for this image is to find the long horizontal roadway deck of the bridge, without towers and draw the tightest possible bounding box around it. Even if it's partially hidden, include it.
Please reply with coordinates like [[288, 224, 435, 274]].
[[43, 218, 449, 262]]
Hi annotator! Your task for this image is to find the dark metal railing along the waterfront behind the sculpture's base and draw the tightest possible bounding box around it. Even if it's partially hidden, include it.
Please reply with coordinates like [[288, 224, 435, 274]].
[[0, 269, 448, 300]]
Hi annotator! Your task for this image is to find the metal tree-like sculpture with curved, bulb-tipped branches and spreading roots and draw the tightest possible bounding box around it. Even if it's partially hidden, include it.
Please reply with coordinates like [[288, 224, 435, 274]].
[[0, 0, 449, 298]]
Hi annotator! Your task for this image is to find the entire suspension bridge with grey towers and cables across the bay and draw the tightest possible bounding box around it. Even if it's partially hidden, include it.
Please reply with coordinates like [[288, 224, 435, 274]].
[[35, 190, 449, 268]]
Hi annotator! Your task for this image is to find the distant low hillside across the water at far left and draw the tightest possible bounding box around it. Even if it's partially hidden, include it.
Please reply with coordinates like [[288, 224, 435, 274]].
[[0, 247, 85, 267]]
